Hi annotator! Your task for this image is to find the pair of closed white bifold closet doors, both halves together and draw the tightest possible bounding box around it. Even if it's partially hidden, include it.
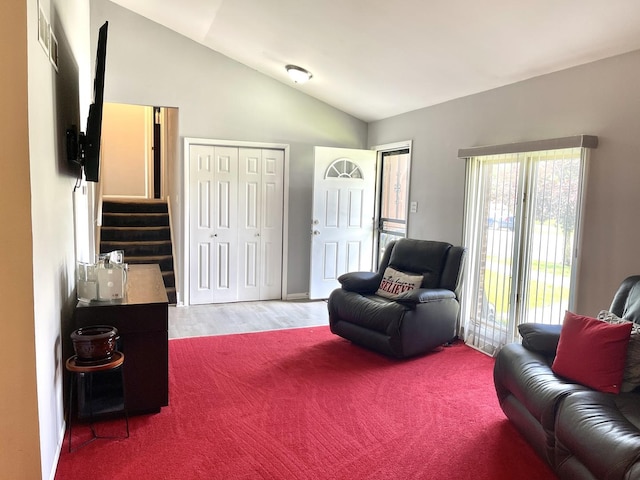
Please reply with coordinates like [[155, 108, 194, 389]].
[[189, 145, 284, 304]]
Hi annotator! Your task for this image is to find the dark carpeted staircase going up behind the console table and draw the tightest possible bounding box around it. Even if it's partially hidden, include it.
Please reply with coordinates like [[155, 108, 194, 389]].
[[100, 200, 176, 304]]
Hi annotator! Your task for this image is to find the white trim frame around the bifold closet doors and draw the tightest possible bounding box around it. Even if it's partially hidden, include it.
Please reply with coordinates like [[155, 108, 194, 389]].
[[181, 137, 290, 306]]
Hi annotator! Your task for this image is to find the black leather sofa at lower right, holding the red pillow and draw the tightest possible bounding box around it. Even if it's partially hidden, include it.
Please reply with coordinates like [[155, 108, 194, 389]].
[[494, 275, 640, 480]]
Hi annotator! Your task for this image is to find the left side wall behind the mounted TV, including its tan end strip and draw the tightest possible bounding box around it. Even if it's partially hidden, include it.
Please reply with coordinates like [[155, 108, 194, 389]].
[[16, 0, 90, 479]]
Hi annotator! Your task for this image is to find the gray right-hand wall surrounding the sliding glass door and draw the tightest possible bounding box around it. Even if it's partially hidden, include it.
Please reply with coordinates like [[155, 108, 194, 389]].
[[369, 51, 640, 315]]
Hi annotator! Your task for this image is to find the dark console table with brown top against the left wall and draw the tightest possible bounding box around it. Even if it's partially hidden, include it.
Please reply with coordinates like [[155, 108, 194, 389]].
[[74, 264, 169, 415]]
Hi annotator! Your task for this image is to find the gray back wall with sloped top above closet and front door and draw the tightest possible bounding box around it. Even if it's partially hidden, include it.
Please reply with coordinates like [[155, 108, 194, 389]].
[[91, 0, 367, 294]]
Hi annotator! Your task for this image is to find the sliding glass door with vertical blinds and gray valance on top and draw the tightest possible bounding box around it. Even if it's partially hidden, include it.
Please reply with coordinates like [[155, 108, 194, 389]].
[[461, 136, 597, 355]]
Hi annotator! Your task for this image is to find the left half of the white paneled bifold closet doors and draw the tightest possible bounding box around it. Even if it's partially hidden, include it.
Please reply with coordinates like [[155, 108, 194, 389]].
[[189, 145, 238, 304]]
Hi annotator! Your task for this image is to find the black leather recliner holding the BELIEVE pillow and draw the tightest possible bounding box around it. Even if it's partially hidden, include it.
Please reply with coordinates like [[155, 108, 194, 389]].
[[328, 238, 465, 358]]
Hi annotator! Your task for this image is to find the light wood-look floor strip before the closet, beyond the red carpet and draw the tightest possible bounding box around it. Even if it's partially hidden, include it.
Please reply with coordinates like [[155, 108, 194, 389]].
[[169, 300, 329, 338]]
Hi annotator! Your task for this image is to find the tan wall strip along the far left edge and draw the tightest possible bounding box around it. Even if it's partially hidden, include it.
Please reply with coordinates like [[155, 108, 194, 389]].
[[0, 2, 40, 479]]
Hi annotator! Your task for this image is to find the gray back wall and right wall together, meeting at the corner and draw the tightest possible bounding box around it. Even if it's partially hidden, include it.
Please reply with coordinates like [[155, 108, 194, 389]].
[[91, 0, 640, 314]]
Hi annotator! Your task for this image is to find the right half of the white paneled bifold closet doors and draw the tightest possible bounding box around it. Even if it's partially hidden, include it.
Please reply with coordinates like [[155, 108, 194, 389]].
[[238, 148, 284, 301]]
